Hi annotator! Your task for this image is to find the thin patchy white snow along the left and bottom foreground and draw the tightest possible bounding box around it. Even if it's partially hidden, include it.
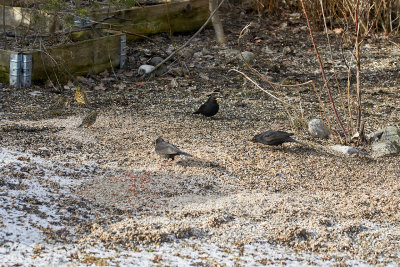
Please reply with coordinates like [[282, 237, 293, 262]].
[[0, 148, 376, 266]]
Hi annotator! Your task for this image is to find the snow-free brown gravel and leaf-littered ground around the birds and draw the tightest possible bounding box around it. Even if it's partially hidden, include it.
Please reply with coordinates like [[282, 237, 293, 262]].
[[0, 5, 400, 265]]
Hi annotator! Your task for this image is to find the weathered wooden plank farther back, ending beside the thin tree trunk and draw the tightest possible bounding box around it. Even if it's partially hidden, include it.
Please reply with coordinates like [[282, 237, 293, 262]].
[[91, 0, 210, 39]]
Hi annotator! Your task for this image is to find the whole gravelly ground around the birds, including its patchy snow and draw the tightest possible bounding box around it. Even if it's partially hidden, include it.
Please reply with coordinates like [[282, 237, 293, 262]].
[[0, 6, 400, 266]]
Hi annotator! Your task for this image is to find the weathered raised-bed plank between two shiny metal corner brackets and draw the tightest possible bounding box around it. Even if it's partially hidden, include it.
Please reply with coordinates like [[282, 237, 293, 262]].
[[28, 30, 123, 82]]
